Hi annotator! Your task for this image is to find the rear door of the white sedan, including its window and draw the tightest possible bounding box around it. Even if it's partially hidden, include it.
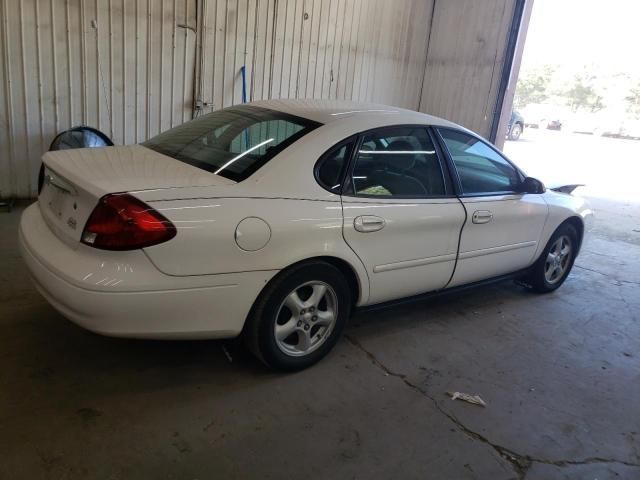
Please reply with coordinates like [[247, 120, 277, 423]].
[[342, 125, 465, 303]]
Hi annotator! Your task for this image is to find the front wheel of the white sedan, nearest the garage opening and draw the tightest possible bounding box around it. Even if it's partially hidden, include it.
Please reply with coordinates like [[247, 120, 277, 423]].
[[527, 223, 578, 293]]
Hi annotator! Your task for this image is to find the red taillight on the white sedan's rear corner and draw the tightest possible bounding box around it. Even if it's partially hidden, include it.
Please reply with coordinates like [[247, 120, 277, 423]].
[[82, 193, 176, 250]]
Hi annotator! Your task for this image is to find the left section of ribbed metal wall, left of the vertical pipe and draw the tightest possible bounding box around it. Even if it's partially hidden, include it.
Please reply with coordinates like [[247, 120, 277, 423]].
[[0, 0, 196, 197]]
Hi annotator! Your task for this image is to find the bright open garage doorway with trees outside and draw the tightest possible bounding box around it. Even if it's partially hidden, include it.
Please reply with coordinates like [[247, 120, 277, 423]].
[[504, 0, 640, 244]]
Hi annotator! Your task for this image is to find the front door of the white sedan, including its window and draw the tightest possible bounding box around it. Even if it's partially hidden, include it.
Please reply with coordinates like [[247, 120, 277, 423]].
[[438, 128, 548, 286]]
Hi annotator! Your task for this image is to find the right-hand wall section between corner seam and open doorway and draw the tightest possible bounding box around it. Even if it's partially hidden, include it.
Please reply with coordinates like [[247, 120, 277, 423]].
[[420, 0, 515, 136]]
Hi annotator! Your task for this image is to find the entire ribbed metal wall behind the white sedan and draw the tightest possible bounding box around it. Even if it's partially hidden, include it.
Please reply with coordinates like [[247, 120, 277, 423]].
[[0, 0, 514, 197]]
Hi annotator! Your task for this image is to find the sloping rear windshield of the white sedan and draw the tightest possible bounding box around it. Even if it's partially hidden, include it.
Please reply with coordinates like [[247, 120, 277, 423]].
[[142, 105, 320, 182]]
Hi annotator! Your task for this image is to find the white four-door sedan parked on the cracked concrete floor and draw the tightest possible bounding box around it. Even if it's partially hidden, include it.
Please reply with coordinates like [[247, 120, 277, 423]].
[[20, 100, 591, 370]]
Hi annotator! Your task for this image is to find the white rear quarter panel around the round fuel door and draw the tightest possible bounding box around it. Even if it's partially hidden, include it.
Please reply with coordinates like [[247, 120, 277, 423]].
[[140, 196, 369, 303]]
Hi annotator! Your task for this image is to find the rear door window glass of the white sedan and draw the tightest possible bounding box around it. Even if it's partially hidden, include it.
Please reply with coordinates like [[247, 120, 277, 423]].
[[351, 126, 445, 197]]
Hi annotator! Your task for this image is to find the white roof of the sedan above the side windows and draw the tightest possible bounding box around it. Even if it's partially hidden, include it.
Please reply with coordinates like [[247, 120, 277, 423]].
[[250, 99, 463, 128]]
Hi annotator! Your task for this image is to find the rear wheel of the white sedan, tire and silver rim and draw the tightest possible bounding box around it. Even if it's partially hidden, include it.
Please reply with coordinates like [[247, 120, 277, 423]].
[[244, 261, 351, 371]]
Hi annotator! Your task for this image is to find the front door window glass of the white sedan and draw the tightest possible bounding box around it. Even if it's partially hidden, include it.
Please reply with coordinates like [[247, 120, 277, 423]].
[[439, 129, 522, 195]]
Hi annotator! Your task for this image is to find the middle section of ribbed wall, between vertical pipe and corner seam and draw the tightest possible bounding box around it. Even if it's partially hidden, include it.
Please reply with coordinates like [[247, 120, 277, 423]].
[[198, 0, 432, 109]]
